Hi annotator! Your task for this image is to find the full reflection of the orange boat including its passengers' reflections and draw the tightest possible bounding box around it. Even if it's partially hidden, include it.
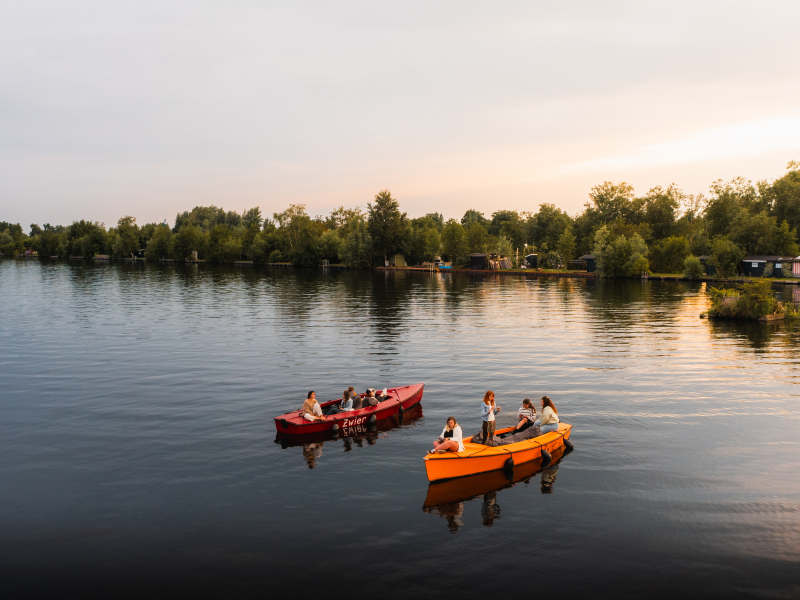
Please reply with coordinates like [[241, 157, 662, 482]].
[[422, 446, 570, 533]]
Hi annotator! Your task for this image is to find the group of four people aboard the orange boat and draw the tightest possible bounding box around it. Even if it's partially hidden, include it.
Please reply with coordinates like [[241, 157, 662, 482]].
[[429, 390, 559, 454]]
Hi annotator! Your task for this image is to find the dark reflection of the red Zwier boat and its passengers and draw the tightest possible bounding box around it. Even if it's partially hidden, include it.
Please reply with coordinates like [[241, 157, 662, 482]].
[[275, 404, 423, 469]]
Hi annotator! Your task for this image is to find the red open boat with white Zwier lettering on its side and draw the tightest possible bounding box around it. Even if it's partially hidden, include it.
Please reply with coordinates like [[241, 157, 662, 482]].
[[275, 383, 425, 435]]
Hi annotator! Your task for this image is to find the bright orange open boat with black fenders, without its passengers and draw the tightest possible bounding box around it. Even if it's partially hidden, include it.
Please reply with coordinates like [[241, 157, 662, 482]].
[[424, 423, 572, 481]]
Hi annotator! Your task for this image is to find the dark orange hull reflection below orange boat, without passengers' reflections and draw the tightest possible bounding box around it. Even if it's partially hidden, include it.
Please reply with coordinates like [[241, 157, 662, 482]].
[[423, 446, 565, 508]]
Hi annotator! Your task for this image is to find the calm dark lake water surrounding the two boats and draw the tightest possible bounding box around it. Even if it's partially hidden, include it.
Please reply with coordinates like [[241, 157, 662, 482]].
[[0, 260, 800, 598]]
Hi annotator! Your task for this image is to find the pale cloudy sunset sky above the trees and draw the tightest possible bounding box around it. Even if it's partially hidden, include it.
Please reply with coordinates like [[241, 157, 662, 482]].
[[0, 0, 800, 228]]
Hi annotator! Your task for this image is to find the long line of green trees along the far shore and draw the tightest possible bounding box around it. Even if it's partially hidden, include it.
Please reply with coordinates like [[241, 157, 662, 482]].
[[0, 161, 800, 277]]
